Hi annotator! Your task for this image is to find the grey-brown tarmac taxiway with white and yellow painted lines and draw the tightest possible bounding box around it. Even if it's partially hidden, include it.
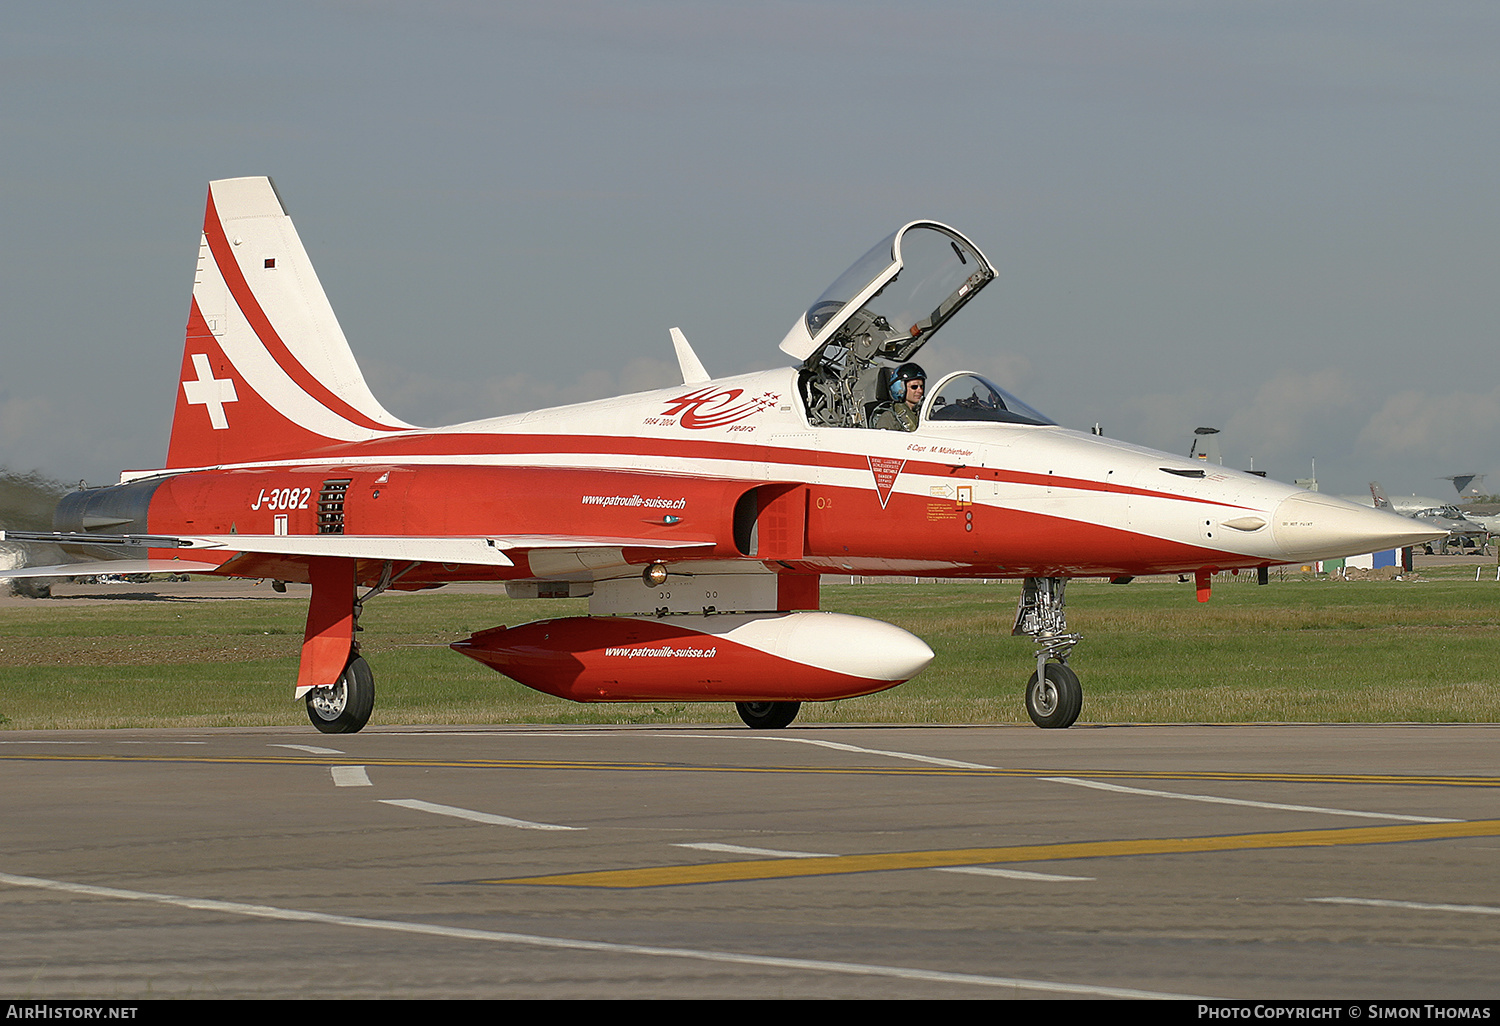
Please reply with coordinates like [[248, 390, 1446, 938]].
[[0, 725, 1500, 1001]]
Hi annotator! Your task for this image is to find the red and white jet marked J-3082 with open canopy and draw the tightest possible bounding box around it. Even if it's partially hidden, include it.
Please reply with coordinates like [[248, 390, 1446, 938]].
[[0, 179, 1439, 734]]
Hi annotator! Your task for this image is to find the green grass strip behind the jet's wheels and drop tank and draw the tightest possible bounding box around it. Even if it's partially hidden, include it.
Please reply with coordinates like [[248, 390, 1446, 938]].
[[0, 570, 1500, 729]]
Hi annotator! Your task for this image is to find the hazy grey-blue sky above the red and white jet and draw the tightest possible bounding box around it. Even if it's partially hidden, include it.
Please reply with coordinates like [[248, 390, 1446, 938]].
[[0, 0, 1500, 495]]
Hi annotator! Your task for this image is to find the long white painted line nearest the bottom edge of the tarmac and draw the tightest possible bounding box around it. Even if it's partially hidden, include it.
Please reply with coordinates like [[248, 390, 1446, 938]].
[[0, 873, 1208, 1001]]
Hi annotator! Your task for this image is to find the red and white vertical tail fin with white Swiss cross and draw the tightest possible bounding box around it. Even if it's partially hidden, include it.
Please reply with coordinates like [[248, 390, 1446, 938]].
[[167, 179, 411, 468]]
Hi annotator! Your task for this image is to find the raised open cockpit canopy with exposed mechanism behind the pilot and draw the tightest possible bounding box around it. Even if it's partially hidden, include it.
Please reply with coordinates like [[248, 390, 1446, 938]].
[[782, 221, 995, 428]]
